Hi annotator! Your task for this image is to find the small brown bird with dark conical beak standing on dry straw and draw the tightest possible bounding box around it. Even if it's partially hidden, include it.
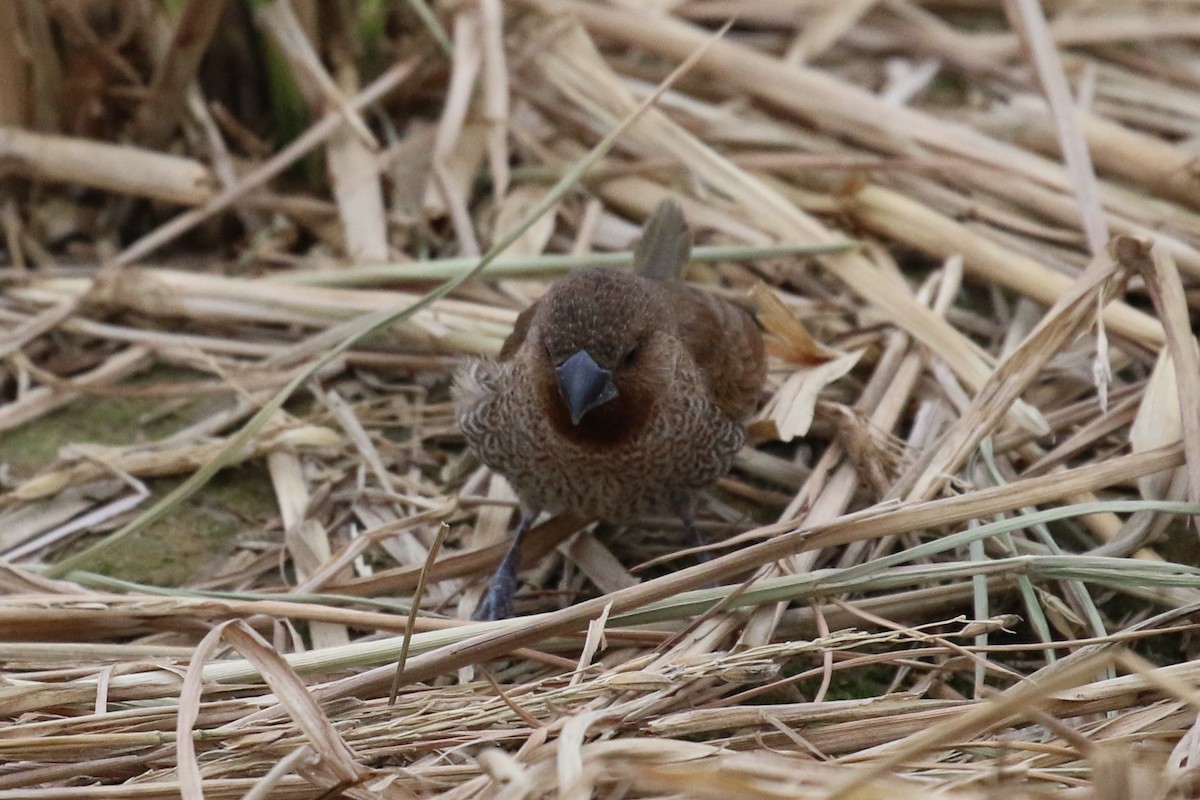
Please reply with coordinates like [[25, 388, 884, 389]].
[[454, 200, 767, 620]]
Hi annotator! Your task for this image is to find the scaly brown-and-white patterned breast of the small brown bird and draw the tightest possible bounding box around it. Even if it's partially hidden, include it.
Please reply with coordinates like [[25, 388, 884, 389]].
[[460, 359, 745, 522]]
